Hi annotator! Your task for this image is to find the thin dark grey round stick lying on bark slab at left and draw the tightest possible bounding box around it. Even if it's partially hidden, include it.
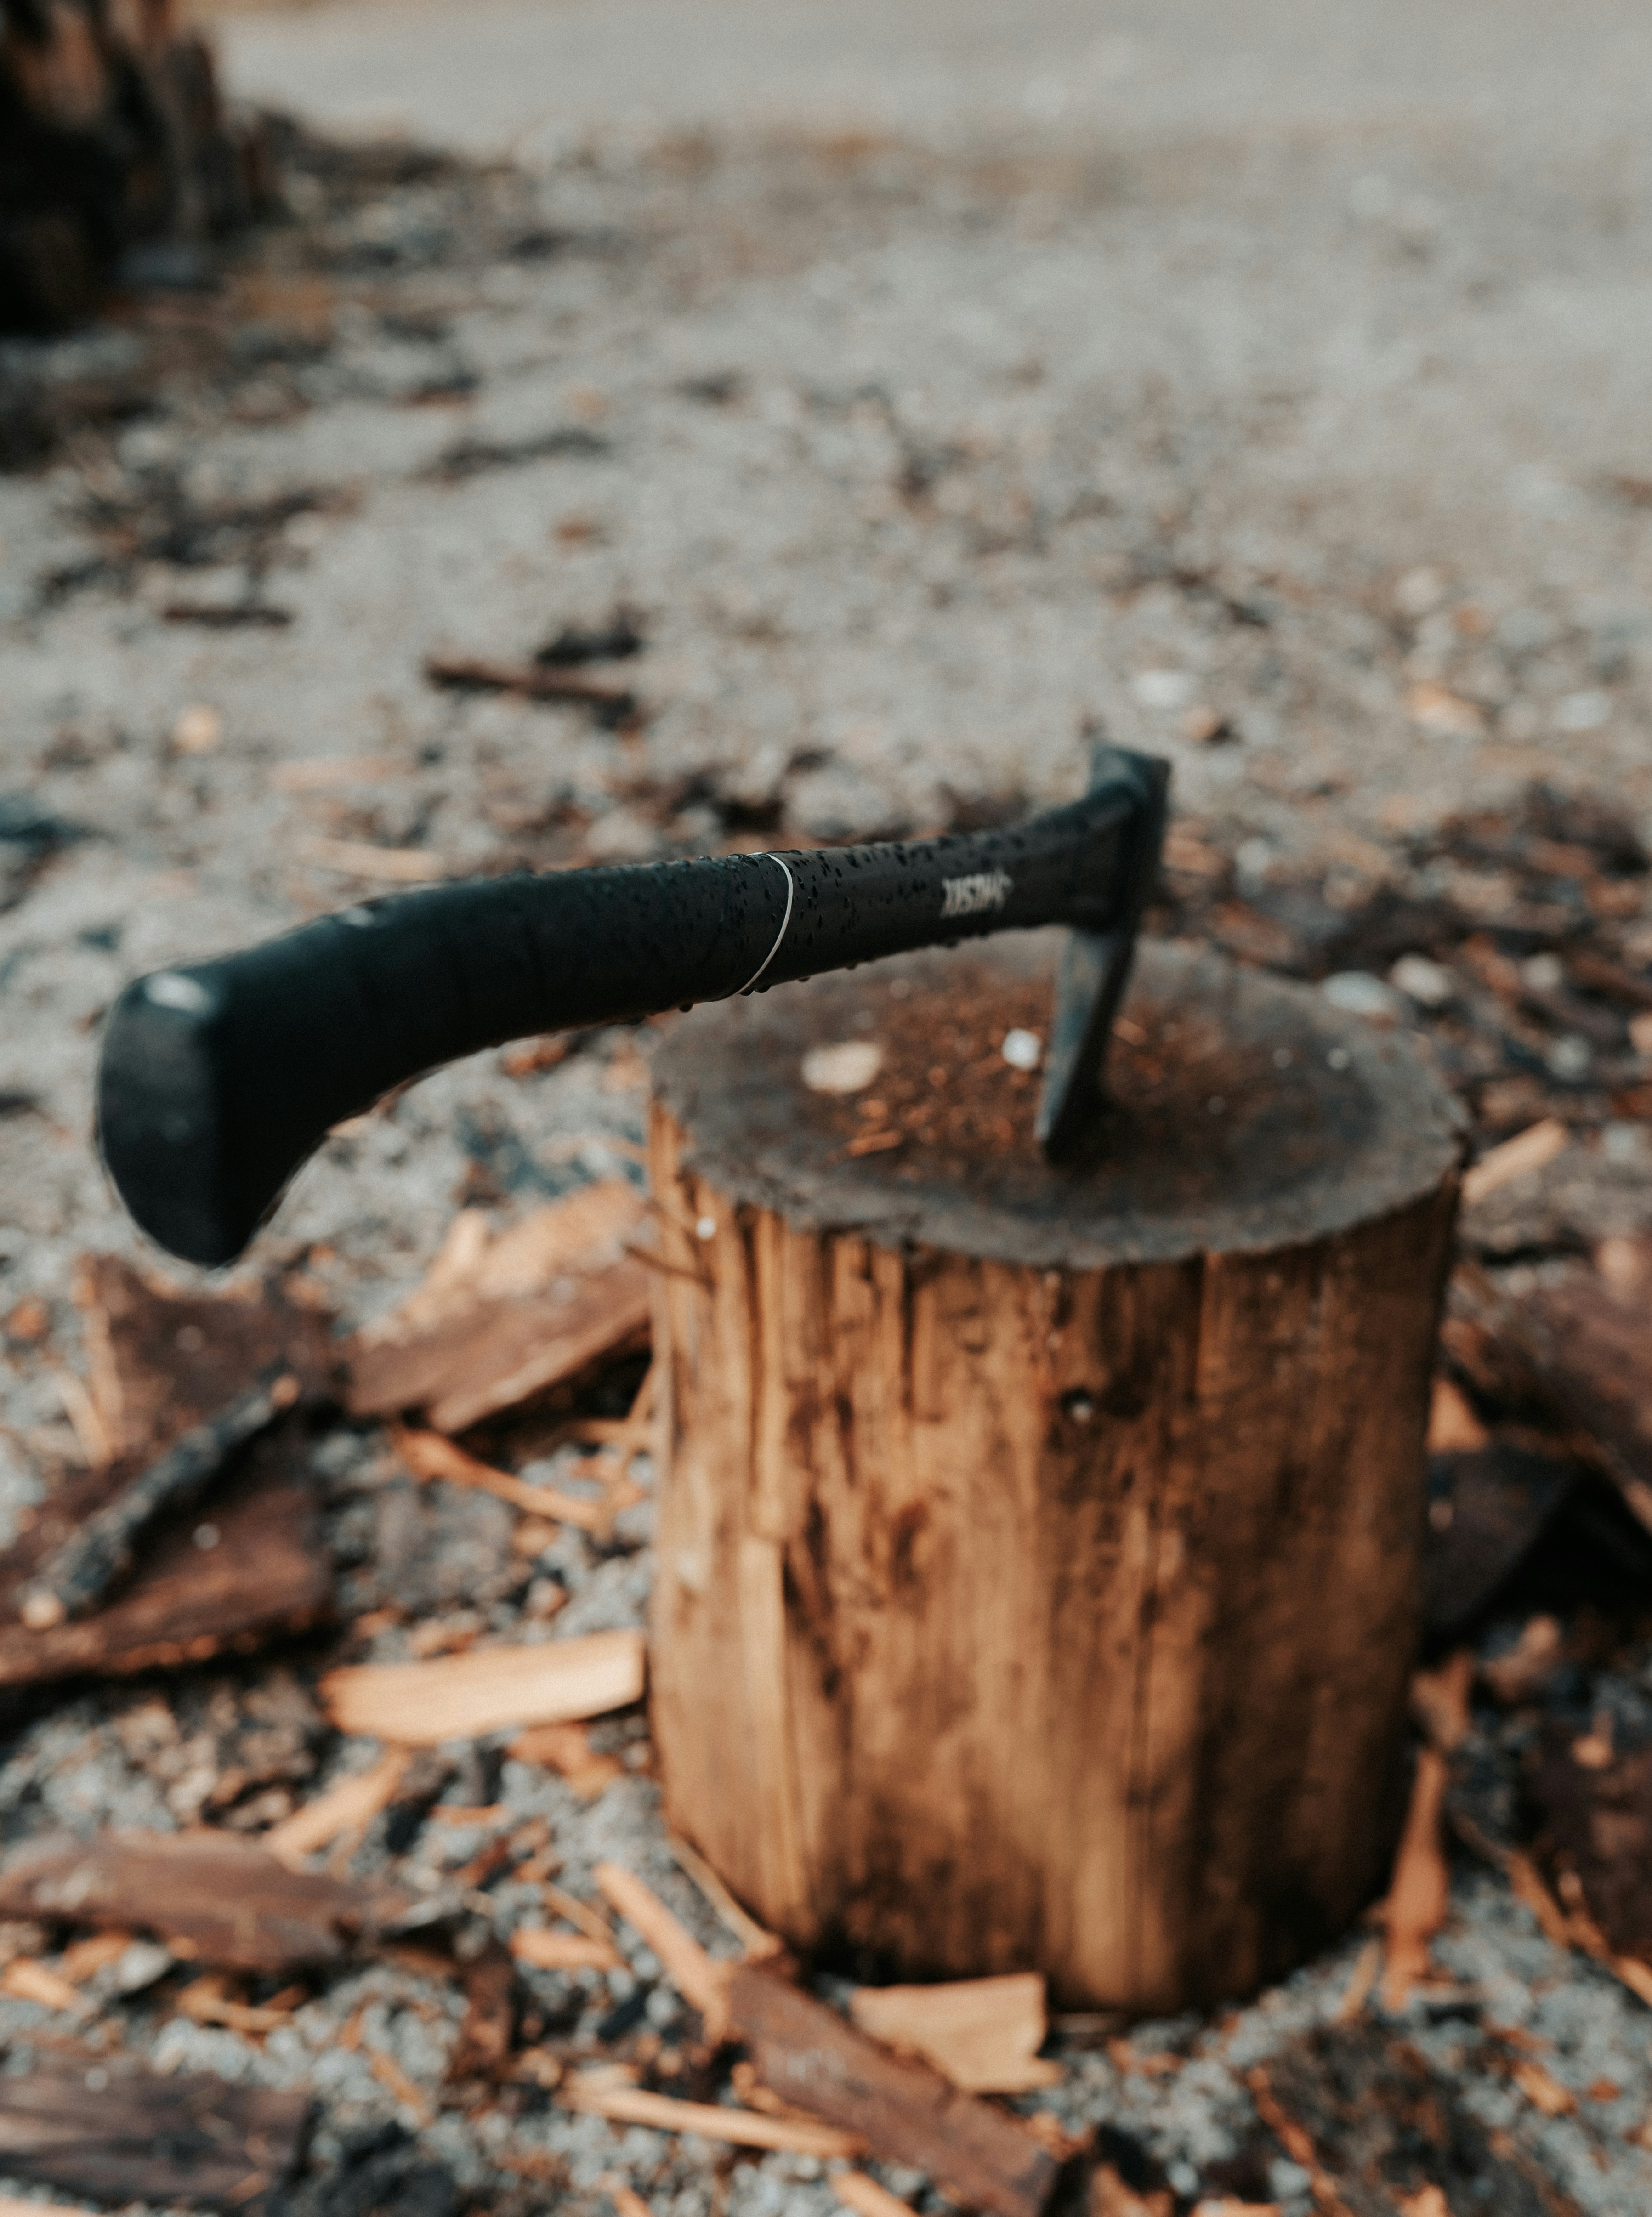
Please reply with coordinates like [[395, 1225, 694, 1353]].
[[20, 1361, 299, 1632]]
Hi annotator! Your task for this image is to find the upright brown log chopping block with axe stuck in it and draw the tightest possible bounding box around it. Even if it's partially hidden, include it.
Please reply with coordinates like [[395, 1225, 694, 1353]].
[[652, 933, 1459, 2011]]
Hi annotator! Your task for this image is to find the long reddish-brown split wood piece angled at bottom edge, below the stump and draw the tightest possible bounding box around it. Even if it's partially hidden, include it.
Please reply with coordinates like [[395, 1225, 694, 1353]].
[[730, 1964, 1058, 2217]]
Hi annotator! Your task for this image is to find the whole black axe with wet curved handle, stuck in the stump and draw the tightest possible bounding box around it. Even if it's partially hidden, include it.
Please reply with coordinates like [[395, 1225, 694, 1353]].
[[97, 747, 1169, 1266]]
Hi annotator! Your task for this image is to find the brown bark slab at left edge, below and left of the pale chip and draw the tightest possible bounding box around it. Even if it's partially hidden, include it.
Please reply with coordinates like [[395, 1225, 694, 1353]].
[[0, 1831, 410, 1971]]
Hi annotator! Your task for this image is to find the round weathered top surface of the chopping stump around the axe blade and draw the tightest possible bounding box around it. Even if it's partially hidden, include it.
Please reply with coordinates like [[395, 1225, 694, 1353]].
[[654, 931, 1459, 1268]]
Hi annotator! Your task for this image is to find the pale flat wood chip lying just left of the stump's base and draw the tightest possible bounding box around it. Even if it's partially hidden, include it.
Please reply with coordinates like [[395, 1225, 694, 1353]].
[[322, 1632, 645, 1747]]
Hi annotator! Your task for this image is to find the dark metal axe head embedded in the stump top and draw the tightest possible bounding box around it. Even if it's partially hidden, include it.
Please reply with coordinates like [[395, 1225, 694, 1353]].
[[1036, 745, 1171, 1162]]
